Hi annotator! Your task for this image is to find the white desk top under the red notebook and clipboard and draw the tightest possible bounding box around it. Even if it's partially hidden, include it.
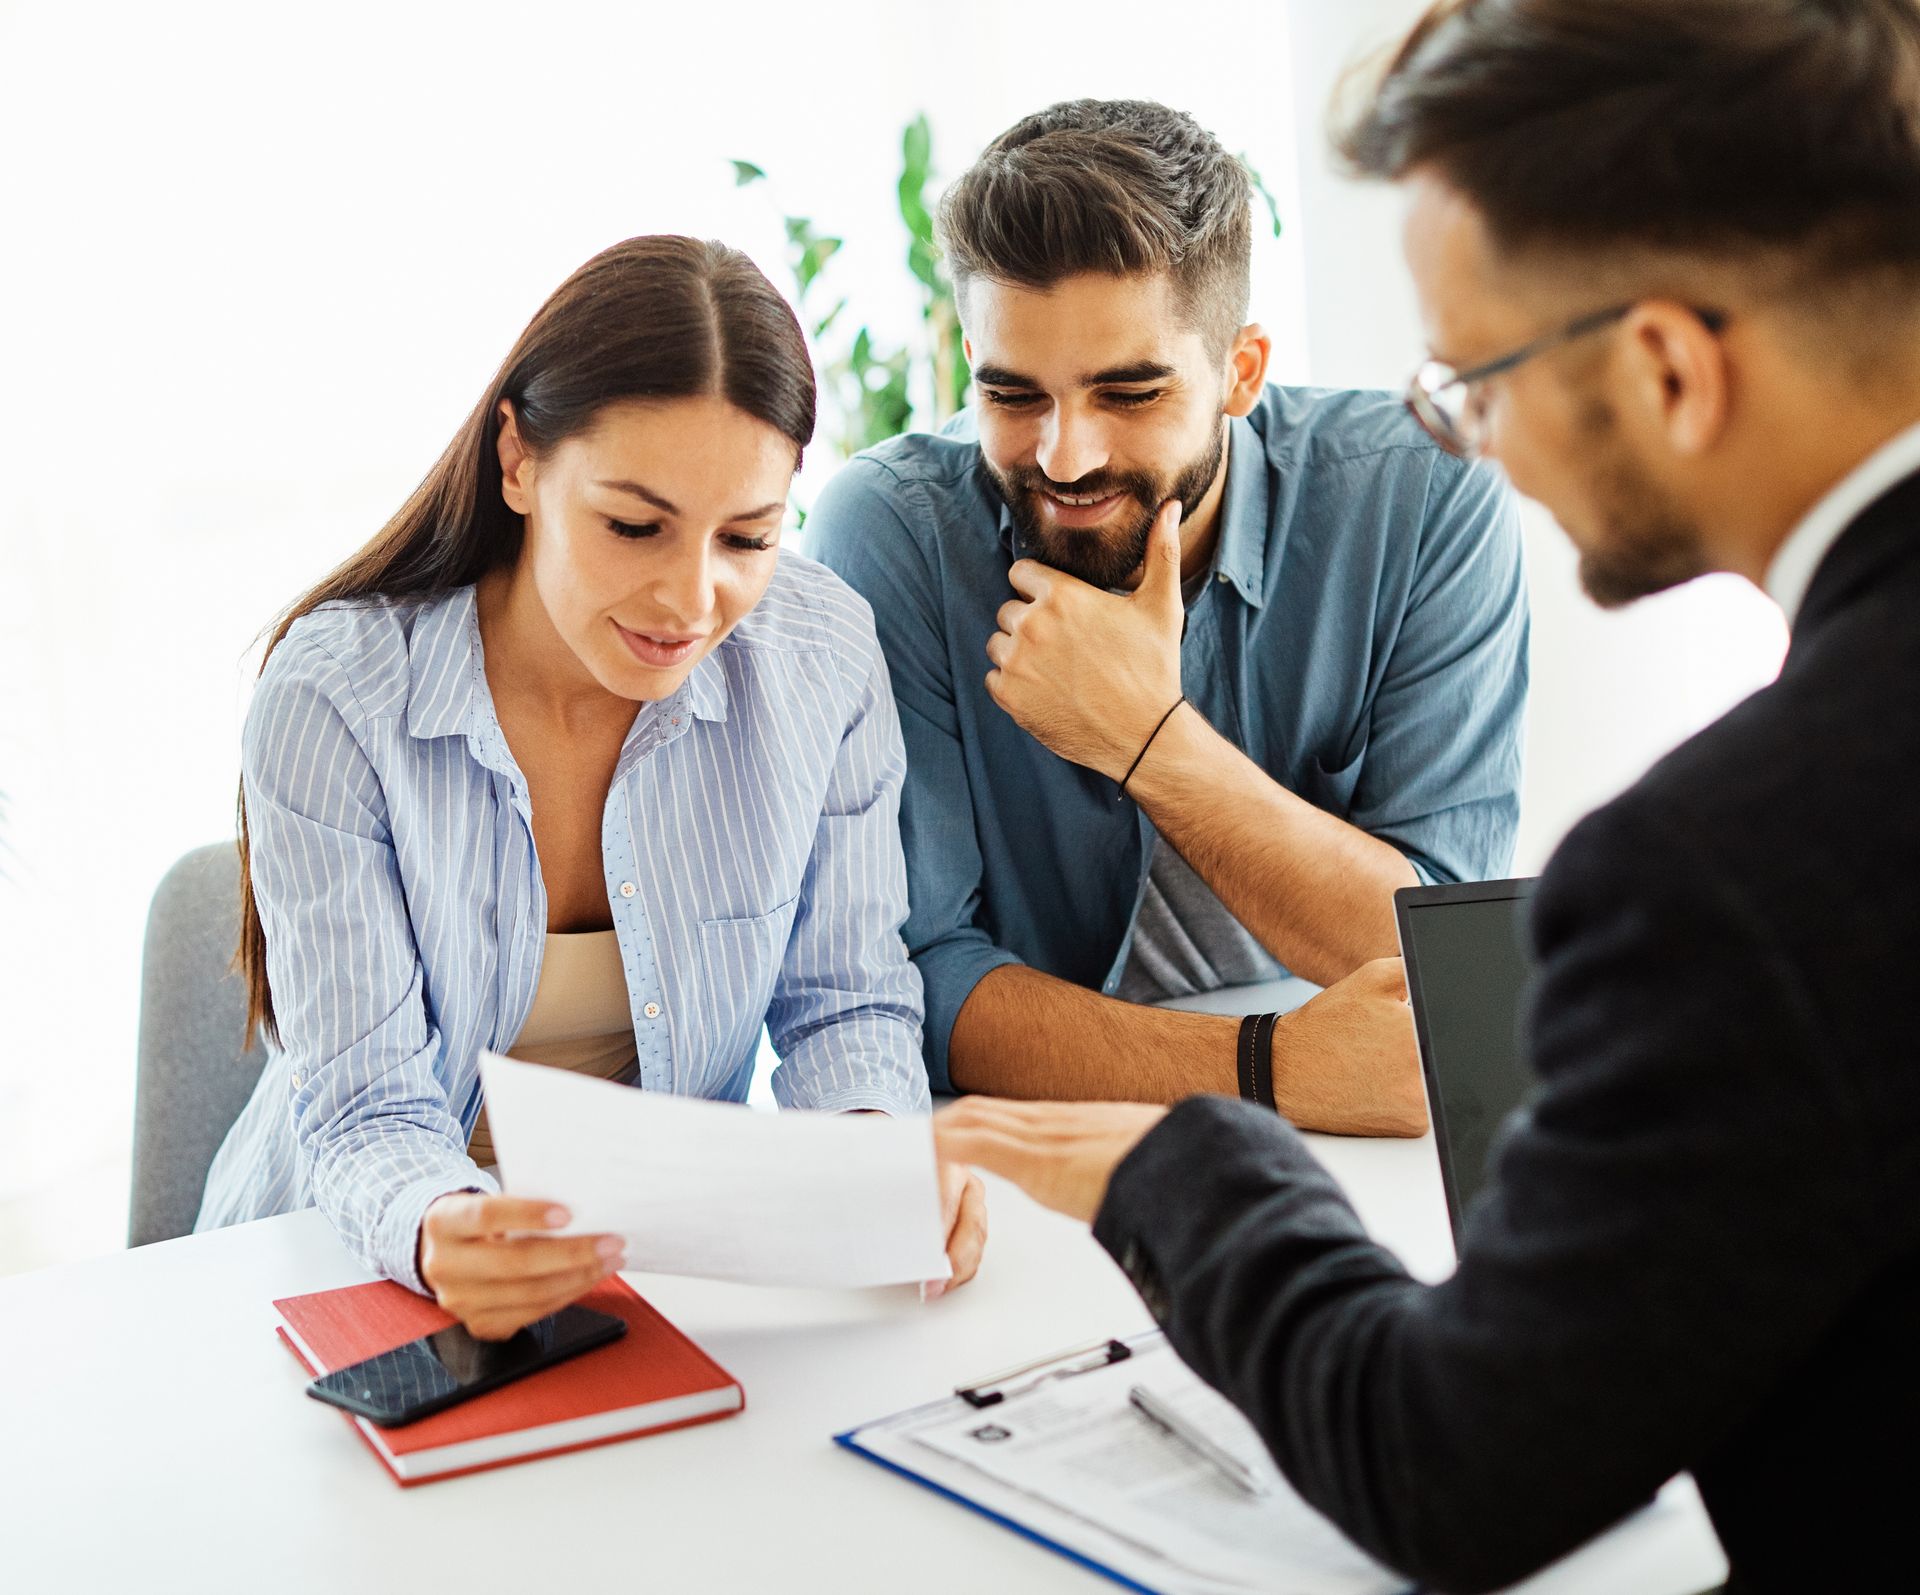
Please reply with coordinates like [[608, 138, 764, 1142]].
[[0, 1138, 1722, 1595]]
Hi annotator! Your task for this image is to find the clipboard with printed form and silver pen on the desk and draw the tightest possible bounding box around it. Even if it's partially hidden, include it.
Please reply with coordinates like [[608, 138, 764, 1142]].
[[835, 1330, 1409, 1595]]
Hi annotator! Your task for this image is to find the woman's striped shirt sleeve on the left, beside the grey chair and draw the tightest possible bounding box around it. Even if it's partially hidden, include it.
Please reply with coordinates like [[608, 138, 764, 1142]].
[[242, 637, 497, 1290]]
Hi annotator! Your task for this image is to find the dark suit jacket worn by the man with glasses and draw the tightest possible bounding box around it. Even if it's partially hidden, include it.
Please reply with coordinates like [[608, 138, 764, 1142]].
[[1094, 476, 1920, 1591]]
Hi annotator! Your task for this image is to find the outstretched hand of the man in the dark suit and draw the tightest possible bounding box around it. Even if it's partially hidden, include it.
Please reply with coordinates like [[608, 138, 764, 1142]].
[[933, 1096, 1167, 1223]]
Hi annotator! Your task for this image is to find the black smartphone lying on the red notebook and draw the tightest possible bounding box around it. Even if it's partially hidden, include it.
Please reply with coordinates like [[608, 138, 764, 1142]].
[[307, 1307, 626, 1428]]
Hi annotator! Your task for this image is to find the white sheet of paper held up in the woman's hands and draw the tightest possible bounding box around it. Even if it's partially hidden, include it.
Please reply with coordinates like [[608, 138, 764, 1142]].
[[480, 1052, 952, 1286]]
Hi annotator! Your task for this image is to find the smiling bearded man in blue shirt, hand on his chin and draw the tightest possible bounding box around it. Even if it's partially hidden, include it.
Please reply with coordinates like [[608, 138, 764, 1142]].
[[806, 100, 1526, 1134]]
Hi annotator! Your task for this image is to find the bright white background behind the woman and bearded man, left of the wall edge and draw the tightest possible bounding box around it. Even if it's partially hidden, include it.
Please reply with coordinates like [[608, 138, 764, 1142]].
[[0, 0, 1306, 1271]]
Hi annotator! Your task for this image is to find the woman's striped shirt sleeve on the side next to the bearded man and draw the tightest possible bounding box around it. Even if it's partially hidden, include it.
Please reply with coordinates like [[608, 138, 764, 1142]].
[[766, 639, 931, 1113]]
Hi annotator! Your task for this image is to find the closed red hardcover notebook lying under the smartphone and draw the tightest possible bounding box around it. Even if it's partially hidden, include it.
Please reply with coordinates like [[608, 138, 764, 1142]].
[[273, 1278, 747, 1486]]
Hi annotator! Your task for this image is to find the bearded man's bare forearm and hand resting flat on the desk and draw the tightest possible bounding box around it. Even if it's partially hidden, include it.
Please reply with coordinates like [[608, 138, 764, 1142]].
[[947, 964, 1427, 1136]]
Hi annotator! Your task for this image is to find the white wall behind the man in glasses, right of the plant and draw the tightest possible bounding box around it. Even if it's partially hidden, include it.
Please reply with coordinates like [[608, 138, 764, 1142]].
[[1286, 0, 1786, 873]]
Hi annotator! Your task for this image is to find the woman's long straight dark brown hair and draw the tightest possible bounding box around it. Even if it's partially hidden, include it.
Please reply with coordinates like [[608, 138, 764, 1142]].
[[234, 234, 814, 1046]]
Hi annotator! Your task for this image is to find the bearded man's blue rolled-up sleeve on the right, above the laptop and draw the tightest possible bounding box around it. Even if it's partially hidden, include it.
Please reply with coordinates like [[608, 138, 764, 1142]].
[[1350, 451, 1528, 883]]
